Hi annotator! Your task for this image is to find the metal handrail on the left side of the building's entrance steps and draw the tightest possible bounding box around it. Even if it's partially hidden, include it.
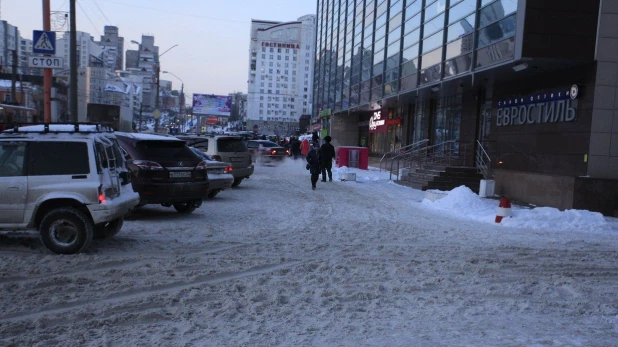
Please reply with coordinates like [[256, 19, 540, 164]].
[[389, 140, 460, 180]]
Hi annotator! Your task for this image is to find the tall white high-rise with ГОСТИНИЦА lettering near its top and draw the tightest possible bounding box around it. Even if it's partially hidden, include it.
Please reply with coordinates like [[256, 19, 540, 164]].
[[246, 15, 315, 134]]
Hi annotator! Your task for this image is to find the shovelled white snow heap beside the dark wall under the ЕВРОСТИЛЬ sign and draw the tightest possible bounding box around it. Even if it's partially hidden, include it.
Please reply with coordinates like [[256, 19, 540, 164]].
[[423, 186, 612, 232]]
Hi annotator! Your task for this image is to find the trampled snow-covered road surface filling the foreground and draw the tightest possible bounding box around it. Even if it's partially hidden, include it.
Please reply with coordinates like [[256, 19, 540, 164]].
[[0, 162, 618, 346]]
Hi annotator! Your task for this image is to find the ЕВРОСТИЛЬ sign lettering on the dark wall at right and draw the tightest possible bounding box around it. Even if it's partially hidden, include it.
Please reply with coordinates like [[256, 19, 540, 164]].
[[496, 85, 579, 126]]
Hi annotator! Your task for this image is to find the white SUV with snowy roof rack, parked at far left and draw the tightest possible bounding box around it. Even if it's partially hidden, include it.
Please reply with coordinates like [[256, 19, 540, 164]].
[[0, 124, 139, 254]]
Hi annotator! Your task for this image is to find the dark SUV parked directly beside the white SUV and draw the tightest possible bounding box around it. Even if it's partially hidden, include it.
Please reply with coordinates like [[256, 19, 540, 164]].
[[116, 133, 210, 213]]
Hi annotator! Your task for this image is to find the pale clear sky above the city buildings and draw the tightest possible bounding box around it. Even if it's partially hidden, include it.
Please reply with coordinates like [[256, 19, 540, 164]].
[[1, 0, 316, 100]]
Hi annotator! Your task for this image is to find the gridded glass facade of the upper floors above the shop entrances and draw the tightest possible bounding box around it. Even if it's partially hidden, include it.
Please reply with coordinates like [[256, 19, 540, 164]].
[[313, 0, 518, 116]]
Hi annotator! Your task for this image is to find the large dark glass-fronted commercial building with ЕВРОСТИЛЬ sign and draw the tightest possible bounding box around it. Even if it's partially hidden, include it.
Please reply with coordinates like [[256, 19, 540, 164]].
[[313, 0, 618, 215]]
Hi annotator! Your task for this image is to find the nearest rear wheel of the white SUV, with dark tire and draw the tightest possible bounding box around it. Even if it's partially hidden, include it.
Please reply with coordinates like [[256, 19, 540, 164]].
[[39, 207, 94, 254]]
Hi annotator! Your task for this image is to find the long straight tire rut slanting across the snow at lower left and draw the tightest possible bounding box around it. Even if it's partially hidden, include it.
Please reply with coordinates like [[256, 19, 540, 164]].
[[0, 261, 301, 322]]
